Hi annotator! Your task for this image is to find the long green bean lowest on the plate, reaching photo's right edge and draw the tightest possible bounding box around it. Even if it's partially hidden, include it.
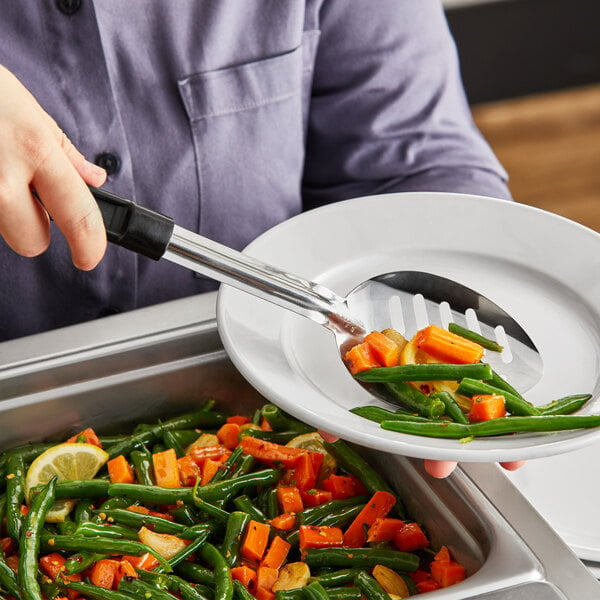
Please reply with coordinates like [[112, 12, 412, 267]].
[[381, 415, 600, 439]]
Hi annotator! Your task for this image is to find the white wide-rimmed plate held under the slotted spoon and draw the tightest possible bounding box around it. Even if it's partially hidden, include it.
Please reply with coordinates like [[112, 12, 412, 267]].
[[217, 192, 600, 462]]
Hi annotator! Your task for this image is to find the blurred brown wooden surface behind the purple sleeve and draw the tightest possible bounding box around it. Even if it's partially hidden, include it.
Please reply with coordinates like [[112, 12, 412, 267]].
[[472, 85, 600, 232]]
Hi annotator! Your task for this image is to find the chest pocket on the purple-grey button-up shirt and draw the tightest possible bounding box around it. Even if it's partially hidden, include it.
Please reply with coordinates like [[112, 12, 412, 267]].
[[178, 32, 318, 249]]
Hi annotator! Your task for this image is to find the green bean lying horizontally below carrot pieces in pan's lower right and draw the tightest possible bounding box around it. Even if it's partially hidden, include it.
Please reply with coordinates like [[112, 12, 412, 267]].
[[304, 548, 419, 573]]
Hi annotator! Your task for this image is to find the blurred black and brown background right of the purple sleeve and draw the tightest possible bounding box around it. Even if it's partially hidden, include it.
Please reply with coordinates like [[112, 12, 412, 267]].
[[443, 0, 600, 231]]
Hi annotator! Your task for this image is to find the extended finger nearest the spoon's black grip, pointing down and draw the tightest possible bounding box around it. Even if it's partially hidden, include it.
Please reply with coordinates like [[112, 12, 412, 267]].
[[32, 147, 106, 271]]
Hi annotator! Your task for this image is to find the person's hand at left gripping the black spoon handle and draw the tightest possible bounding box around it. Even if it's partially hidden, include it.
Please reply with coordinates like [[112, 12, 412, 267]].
[[0, 66, 106, 270]]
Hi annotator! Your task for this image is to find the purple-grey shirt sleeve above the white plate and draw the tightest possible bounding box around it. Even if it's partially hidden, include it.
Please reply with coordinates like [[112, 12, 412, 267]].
[[303, 0, 510, 208]]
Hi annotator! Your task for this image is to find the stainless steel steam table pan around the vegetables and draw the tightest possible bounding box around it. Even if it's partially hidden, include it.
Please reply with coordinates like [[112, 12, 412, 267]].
[[0, 294, 600, 600]]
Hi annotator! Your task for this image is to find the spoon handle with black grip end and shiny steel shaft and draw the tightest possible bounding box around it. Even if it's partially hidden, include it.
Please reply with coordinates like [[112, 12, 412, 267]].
[[90, 187, 361, 332]]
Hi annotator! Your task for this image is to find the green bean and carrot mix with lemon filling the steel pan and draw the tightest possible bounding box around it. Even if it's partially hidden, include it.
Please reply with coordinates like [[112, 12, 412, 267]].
[[0, 401, 465, 600]]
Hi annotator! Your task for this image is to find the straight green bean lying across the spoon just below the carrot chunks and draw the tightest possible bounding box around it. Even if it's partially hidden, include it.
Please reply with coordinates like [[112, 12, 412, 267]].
[[354, 363, 492, 383]]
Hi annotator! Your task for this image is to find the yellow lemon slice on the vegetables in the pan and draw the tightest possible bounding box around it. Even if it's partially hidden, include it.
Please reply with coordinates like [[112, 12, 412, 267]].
[[25, 443, 108, 523]]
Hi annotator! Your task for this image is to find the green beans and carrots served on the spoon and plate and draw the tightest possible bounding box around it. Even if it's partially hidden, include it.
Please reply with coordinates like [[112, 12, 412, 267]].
[[344, 323, 600, 441]]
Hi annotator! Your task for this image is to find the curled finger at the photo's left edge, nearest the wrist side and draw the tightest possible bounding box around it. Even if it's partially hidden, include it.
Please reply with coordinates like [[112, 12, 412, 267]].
[[0, 180, 50, 257]]
